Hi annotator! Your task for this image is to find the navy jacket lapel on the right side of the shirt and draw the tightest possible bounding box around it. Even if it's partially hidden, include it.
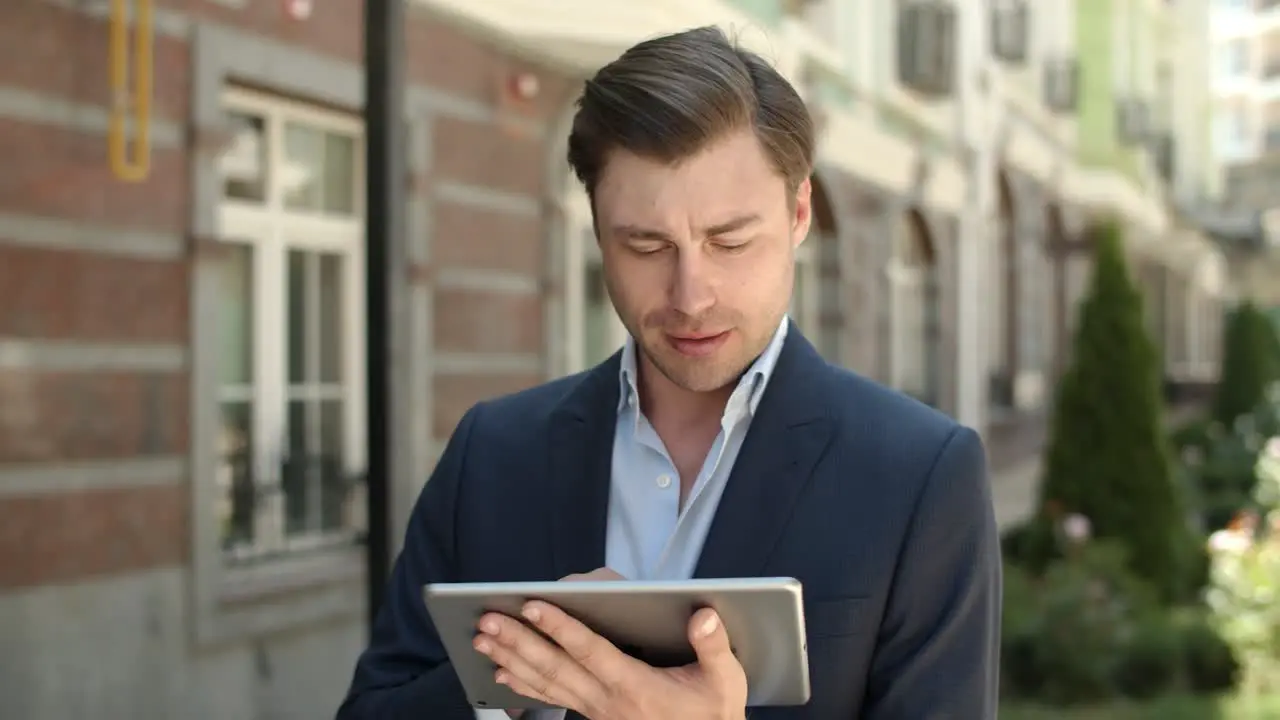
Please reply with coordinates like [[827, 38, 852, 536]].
[[694, 325, 835, 578]]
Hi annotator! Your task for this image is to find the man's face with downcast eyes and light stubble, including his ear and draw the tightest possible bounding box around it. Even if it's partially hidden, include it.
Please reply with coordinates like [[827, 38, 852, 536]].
[[595, 131, 810, 392]]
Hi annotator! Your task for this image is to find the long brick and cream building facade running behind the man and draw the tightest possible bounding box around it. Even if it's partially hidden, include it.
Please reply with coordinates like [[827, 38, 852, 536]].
[[0, 0, 1239, 720]]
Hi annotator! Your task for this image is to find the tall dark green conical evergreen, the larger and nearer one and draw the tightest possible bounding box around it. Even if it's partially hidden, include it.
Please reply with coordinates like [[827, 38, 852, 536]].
[[1039, 225, 1189, 597]]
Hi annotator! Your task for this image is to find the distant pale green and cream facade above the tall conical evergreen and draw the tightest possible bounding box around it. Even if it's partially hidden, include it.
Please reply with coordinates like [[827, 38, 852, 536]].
[[1076, 0, 1233, 386]]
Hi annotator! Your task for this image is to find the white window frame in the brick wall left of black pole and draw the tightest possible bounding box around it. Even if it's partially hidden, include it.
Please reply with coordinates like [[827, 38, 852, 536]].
[[217, 88, 367, 566]]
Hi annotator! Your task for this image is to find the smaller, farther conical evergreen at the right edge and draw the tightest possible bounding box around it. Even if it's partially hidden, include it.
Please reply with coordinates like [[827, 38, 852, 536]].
[[1213, 301, 1280, 428]]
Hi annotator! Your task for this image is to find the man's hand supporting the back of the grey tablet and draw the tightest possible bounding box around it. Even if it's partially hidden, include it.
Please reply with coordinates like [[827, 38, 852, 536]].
[[475, 601, 746, 720]]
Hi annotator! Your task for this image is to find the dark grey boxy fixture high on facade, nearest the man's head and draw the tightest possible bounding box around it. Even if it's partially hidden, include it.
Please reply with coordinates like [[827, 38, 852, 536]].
[[897, 0, 956, 99]]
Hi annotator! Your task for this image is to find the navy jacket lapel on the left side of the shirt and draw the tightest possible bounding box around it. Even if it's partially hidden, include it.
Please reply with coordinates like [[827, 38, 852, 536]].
[[549, 352, 621, 578]]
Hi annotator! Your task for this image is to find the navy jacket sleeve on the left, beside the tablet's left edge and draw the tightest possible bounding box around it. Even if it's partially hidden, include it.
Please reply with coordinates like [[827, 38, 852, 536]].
[[338, 405, 480, 720]]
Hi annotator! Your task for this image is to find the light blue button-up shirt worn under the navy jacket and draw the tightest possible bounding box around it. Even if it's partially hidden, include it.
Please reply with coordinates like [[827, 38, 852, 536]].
[[476, 318, 787, 720]]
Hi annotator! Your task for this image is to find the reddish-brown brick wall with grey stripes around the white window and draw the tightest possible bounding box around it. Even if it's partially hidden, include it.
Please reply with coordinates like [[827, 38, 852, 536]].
[[0, 0, 575, 720]]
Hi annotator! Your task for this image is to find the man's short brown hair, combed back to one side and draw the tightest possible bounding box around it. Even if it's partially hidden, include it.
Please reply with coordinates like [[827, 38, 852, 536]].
[[568, 27, 814, 199]]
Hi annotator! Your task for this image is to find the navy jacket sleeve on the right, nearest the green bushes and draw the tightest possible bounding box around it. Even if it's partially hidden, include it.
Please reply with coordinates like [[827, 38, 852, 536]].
[[861, 427, 1002, 720]]
